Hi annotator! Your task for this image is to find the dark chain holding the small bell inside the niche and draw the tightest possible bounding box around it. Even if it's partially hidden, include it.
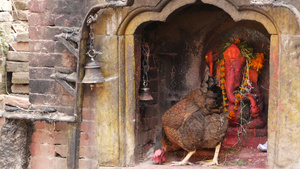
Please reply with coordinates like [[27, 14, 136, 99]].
[[142, 43, 150, 88]]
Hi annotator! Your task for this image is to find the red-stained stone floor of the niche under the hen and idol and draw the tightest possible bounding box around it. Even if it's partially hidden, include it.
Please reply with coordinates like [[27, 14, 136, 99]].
[[129, 128, 268, 169]]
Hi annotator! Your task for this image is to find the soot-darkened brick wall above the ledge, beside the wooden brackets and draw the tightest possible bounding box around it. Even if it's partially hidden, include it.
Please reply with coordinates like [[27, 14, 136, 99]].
[[28, 0, 79, 114]]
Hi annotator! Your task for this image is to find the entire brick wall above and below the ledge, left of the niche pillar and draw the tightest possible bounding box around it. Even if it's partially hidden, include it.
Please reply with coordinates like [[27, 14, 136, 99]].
[[28, 0, 98, 169]]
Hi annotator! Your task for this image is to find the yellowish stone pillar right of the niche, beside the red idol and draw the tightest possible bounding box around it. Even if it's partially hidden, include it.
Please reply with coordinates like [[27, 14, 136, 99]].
[[268, 35, 300, 169]]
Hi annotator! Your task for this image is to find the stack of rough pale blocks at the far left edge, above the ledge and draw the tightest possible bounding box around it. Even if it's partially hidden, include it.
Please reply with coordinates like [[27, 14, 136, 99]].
[[0, 0, 29, 94]]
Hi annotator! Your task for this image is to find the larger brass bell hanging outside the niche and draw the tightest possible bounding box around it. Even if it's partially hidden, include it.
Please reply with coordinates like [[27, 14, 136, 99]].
[[82, 59, 105, 90]]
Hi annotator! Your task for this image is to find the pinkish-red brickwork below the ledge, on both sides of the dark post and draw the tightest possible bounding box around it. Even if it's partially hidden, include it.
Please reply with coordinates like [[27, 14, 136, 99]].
[[29, 109, 98, 169]]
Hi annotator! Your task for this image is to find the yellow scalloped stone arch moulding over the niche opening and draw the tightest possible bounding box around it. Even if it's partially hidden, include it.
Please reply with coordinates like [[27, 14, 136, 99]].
[[117, 0, 279, 35]]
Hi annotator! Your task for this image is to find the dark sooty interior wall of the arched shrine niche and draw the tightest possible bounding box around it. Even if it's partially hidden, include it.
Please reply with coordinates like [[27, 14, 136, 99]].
[[135, 3, 270, 165]]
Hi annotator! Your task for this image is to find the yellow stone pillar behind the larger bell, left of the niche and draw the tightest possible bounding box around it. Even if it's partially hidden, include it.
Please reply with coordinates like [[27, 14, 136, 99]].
[[93, 35, 121, 166]]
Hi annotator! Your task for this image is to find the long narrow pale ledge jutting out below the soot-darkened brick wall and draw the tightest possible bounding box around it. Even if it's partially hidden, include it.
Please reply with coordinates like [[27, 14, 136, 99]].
[[0, 110, 76, 122]]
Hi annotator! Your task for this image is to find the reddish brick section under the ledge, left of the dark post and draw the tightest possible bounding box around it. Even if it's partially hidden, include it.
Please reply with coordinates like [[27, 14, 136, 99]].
[[30, 122, 67, 169]]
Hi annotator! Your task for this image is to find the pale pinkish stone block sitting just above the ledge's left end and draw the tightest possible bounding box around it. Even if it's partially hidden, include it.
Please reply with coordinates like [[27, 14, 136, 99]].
[[4, 95, 30, 109]]
